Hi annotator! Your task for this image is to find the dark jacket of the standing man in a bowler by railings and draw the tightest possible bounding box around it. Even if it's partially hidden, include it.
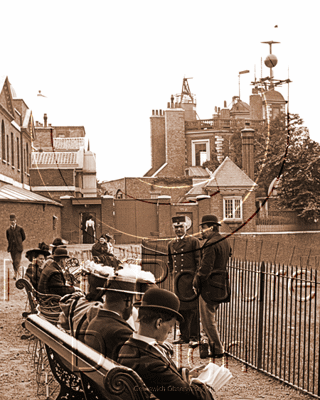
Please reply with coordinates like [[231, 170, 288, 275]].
[[195, 232, 231, 303]]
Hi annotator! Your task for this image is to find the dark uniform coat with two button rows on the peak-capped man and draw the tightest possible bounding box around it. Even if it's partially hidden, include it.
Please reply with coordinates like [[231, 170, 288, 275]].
[[168, 235, 200, 310]]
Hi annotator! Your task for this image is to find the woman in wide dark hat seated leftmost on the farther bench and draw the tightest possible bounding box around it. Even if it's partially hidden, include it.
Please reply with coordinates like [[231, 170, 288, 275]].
[[25, 242, 50, 290]]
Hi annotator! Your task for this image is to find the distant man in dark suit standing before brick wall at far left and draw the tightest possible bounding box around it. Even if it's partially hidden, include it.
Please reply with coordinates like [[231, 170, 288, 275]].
[[6, 214, 26, 279]]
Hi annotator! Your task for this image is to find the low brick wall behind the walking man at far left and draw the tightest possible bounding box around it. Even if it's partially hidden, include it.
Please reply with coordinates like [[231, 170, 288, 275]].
[[0, 201, 61, 252]]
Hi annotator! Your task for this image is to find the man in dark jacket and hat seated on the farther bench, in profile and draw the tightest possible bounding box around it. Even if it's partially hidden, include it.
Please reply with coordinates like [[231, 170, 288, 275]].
[[38, 247, 80, 296]]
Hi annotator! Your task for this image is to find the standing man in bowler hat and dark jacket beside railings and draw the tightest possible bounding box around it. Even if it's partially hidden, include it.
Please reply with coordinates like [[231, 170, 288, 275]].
[[193, 215, 231, 358]]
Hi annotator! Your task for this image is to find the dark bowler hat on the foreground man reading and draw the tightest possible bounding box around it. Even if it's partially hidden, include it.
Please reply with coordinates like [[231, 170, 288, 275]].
[[136, 287, 184, 322]]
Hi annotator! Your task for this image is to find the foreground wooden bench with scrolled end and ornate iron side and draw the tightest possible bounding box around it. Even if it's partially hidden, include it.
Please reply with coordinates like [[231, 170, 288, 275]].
[[25, 315, 156, 400]]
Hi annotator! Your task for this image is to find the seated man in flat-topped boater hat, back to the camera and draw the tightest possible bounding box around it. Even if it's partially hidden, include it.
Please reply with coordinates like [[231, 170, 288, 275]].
[[85, 276, 142, 360]]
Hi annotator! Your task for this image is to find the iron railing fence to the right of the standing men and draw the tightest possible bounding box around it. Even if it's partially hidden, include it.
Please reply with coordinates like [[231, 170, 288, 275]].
[[218, 259, 320, 398]]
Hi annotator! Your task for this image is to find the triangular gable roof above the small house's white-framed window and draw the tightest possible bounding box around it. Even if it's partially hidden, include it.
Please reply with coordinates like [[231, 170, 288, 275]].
[[205, 157, 257, 188]]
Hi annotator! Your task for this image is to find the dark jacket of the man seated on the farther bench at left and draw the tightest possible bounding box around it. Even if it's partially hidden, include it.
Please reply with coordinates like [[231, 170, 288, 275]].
[[38, 260, 75, 296]]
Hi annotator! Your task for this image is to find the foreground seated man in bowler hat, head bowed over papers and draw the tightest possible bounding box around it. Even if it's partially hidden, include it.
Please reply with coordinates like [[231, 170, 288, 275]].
[[118, 288, 213, 400]]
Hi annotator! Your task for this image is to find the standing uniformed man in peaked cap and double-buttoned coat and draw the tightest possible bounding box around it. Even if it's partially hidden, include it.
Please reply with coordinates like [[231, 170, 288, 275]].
[[168, 215, 200, 347]]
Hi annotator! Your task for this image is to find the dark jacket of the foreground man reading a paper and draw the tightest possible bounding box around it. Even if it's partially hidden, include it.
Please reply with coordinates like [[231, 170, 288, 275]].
[[118, 337, 213, 400]]
